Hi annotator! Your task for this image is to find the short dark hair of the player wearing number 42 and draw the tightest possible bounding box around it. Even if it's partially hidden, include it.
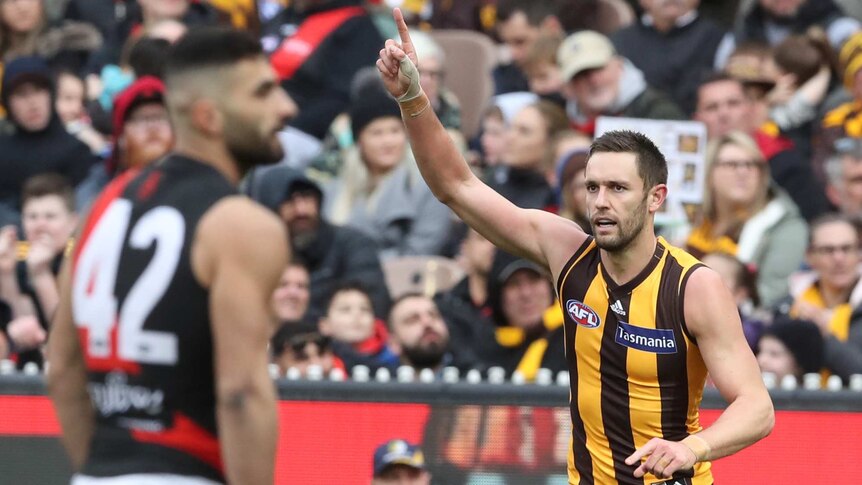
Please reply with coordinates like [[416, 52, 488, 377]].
[[165, 27, 263, 81]]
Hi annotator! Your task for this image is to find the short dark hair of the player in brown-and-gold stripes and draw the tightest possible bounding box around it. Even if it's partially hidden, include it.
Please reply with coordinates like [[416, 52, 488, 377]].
[[590, 130, 667, 191]]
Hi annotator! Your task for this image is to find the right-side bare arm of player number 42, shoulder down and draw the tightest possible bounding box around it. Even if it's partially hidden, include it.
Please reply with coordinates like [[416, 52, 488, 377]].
[[192, 197, 288, 484]]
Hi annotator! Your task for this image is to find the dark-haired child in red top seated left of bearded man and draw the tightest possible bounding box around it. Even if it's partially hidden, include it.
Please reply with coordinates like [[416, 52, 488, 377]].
[[318, 283, 398, 369]]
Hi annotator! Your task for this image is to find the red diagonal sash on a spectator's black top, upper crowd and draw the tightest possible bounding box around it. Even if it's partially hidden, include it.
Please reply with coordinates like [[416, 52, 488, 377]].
[[270, 7, 365, 79]]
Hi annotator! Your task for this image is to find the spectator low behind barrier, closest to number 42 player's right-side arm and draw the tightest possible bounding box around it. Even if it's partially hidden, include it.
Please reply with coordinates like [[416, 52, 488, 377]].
[[270, 320, 346, 378]]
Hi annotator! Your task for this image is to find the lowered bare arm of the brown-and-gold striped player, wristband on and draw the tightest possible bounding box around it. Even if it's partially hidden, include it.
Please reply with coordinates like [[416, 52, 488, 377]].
[[627, 268, 775, 477]]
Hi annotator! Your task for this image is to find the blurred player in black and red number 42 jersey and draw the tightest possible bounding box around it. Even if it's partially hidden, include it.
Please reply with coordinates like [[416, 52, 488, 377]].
[[48, 29, 292, 485]]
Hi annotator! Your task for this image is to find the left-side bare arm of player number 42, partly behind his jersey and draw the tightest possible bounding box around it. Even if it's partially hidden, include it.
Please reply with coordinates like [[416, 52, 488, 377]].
[[47, 258, 95, 469]]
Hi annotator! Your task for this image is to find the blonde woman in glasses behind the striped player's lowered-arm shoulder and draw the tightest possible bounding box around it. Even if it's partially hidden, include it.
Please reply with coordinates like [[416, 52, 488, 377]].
[[686, 131, 808, 307]]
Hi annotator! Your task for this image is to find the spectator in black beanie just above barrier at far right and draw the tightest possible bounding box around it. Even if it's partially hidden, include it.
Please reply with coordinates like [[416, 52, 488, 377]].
[[757, 316, 823, 382]]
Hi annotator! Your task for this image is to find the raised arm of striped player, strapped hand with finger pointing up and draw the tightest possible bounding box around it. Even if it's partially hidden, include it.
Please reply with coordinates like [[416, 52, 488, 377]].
[[377, 9, 586, 265]]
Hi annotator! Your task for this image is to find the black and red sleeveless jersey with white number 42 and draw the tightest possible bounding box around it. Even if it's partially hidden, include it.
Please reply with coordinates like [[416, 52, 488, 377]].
[[72, 155, 236, 481]]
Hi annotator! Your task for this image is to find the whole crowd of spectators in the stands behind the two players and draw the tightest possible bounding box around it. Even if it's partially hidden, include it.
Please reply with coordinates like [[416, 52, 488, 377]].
[[0, 0, 862, 390]]
